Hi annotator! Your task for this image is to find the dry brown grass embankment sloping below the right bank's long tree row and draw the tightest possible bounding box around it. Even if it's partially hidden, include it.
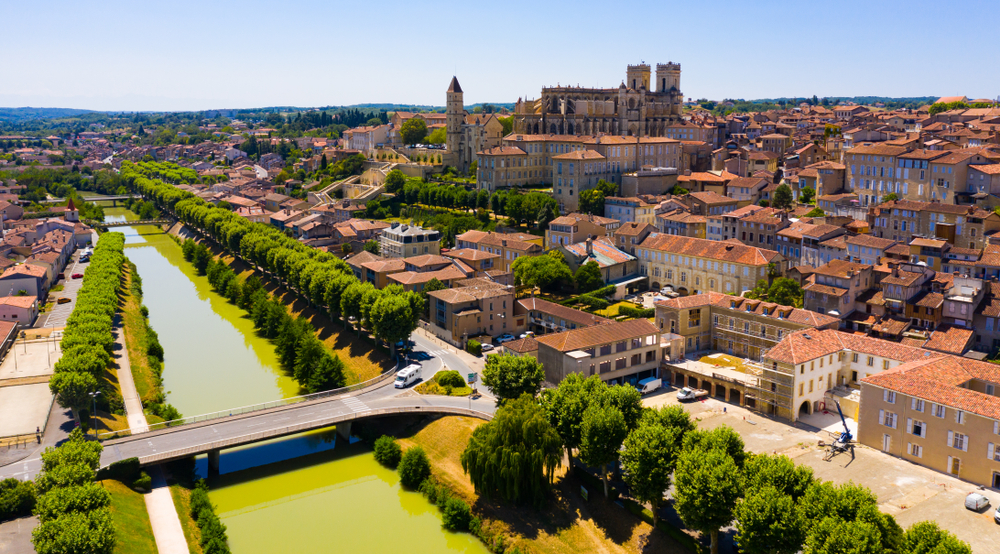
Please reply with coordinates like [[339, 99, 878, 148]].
[[171, 227, 393, 385]]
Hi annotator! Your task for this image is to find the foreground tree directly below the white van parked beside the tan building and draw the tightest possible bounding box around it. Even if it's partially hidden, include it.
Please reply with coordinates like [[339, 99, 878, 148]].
[[621, 418, 681, 527]]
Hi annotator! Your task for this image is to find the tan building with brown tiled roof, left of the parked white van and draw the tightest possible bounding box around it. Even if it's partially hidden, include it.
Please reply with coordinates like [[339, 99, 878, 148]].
[[536, 319, 662, 385]]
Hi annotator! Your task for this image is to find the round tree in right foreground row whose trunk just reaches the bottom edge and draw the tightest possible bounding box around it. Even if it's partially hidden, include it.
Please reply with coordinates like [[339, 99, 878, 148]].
[[674, 448, 742, 554]]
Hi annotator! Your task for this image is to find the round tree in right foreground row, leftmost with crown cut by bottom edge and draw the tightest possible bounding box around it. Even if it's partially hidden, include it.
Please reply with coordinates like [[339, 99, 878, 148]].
[[735, 486, 805, 554]]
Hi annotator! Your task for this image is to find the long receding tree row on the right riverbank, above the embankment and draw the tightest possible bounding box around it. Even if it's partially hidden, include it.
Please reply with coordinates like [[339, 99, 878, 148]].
[[122, 164, 424, 376]]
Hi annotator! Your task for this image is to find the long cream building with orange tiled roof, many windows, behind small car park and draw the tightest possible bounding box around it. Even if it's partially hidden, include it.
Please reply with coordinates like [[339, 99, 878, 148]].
[[636, 233, 785, 295]]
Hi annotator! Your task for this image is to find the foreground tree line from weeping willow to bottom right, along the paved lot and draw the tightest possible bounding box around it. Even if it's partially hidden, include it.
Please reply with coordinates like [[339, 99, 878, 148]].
[[461, 356, 971, 554]]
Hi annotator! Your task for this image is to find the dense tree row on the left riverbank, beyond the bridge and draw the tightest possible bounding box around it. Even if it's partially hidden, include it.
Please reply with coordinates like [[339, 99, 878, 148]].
[[49, 233, 125, 408]]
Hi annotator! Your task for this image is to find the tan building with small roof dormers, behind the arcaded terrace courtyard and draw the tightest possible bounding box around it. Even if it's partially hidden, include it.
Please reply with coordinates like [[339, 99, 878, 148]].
[[655, 292, 840, 360]]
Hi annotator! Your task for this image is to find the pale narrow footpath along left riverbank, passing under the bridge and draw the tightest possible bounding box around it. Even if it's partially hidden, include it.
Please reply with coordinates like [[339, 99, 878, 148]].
[[115, 314, 188, 554]]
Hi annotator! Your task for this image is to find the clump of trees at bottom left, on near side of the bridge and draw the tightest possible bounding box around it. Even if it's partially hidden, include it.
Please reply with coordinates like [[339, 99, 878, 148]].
[[31, 429, 115, 554]]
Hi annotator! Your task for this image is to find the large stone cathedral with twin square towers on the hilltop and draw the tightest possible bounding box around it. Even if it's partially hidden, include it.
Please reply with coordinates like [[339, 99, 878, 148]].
[[514, 62, 684, 137]]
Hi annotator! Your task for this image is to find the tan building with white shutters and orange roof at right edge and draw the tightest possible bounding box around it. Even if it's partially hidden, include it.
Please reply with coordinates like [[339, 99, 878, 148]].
[[858, 351, 1000, 488]]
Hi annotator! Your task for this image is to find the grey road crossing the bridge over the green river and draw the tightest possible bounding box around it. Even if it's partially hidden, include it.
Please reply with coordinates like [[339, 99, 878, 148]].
[[0, 328, 495, 479]]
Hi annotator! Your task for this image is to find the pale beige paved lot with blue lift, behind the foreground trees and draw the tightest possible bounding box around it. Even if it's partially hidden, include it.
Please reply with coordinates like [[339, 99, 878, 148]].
[[643, 387, 1000, 554]]
